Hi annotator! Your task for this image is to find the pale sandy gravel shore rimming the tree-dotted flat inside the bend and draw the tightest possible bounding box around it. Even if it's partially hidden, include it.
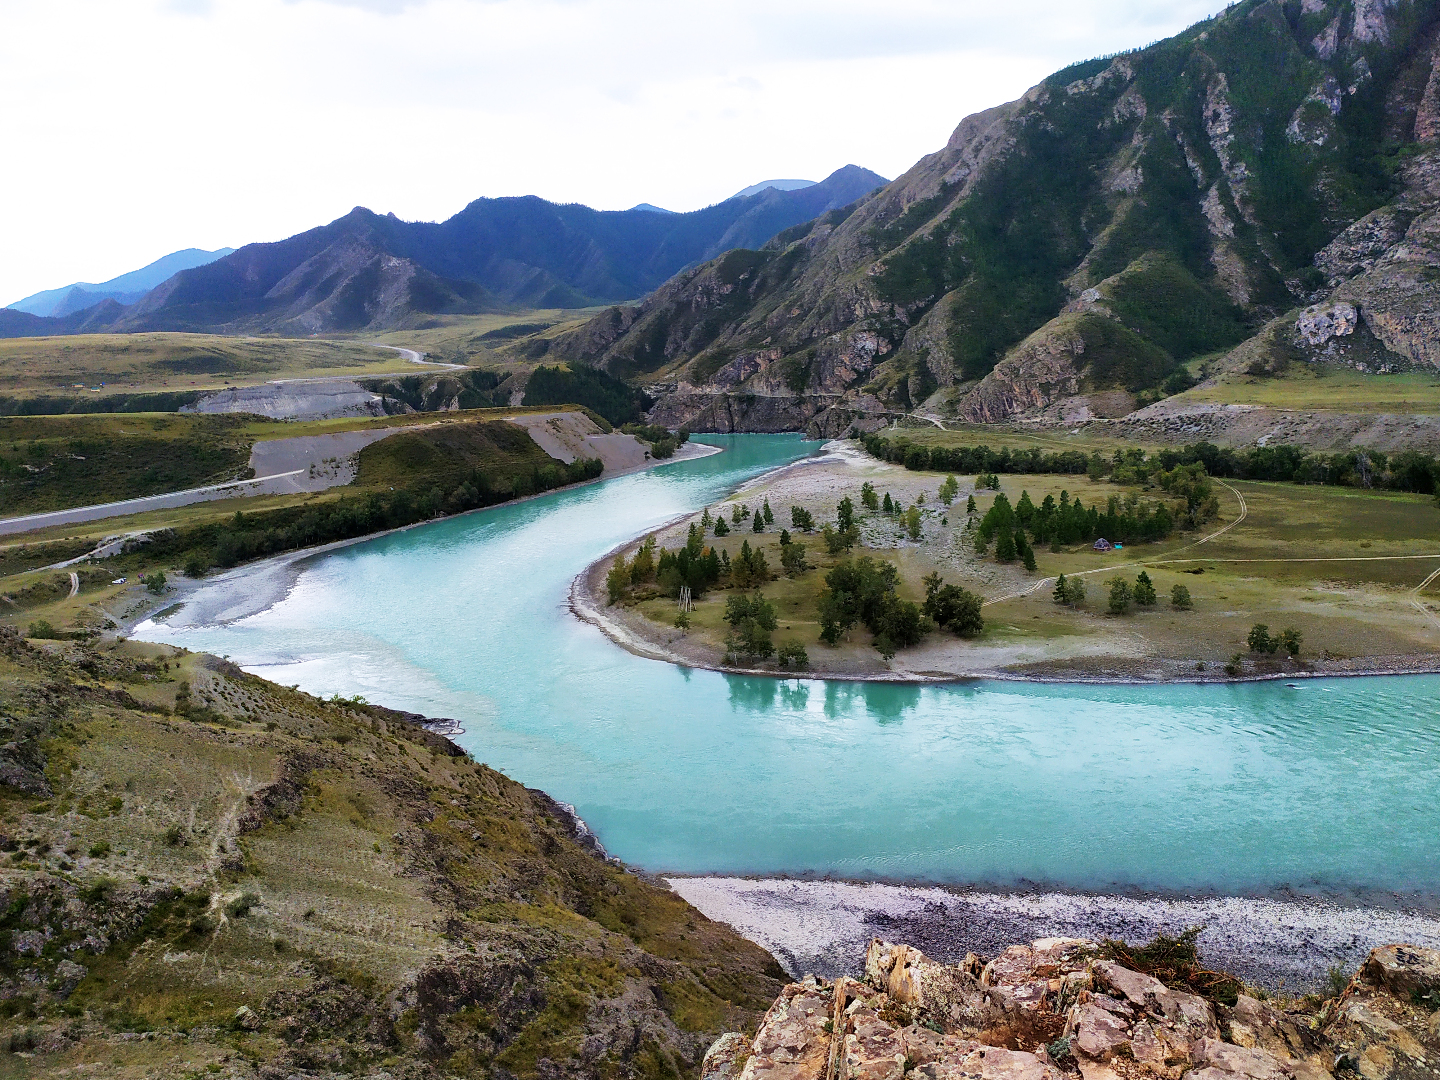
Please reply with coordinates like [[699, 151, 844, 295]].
[[570, 441, 1440, 683]]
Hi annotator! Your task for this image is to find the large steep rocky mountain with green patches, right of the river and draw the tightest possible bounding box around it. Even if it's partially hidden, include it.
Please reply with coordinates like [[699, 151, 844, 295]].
[[549, 0, 1440, 433]]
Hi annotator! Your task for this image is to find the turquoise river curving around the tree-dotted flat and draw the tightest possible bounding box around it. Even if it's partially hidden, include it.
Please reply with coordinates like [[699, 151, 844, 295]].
[[135, 435, 1440, 894]]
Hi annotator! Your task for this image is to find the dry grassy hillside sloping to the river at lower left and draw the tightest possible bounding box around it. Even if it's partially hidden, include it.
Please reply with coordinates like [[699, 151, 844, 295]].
[[0, 631, 780, 1079]]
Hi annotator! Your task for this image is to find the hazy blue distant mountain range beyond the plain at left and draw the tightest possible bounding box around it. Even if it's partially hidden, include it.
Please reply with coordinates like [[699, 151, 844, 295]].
[[0, 166, 886, 336]]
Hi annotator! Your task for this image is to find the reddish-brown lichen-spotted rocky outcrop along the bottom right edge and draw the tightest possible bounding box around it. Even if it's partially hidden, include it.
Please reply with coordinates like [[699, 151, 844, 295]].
[[703, 937, 1440, 1080]]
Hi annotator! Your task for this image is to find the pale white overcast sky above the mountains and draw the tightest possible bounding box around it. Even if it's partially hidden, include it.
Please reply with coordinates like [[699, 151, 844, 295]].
[[0, 0, 1224, 302]]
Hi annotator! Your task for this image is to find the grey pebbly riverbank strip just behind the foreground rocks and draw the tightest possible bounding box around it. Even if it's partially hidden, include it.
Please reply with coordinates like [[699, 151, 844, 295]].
[[667, 877, 1440, 991]]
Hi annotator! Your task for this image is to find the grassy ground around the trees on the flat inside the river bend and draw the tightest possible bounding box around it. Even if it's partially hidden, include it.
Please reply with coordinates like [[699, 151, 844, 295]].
[[616, 455, 1440, 677]]
